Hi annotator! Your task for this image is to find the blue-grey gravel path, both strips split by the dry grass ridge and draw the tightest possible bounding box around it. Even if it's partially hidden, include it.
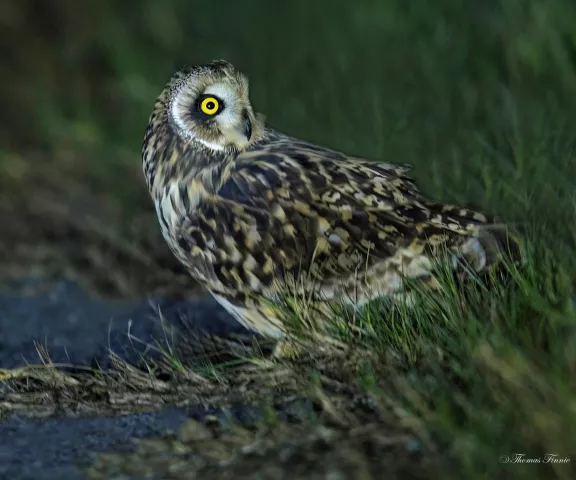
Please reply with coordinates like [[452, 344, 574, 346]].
[[0, 283, 251, 480]]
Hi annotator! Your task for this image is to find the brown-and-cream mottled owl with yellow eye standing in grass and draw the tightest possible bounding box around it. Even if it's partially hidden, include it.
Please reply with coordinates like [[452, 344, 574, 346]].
[[142, 60, 508, 352]]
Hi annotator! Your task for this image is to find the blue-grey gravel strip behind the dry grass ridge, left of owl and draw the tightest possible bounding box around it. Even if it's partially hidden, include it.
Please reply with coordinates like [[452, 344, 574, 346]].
[[0, 283, 245, 368]]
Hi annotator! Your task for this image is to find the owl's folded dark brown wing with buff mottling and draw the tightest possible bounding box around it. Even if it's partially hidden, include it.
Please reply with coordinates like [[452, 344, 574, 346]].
[[174, 138, 496, 295]]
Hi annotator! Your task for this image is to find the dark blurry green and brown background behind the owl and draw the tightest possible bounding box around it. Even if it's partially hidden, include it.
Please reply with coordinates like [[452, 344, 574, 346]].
[[0, 0, 576, 297]]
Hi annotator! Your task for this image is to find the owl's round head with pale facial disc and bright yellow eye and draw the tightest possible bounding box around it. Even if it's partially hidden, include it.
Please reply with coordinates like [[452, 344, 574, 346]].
[[161, 60, 263, 152]]
